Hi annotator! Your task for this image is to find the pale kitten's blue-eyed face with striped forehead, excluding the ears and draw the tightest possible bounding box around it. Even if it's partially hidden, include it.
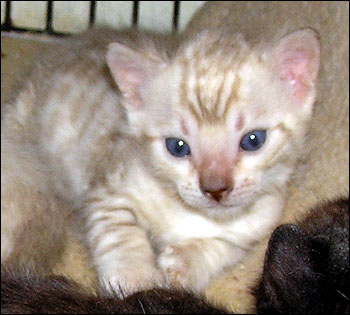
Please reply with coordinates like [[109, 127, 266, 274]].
[[140, 58, 303, 217]]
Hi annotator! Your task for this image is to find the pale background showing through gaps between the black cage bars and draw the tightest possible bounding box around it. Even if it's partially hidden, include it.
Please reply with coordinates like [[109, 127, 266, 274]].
[[1, 1, 206, 33]]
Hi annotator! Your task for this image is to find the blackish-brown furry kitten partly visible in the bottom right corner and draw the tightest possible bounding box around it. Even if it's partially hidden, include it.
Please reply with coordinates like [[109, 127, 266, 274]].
[[256, 199, 350, 314]]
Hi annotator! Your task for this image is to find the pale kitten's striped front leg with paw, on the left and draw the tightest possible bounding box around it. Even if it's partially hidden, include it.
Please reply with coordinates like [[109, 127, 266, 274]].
[[84, 197, 163, 296]]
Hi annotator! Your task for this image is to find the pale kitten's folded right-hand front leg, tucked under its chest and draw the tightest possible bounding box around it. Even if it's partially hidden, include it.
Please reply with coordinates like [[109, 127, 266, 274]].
[[158, 238, 245, 293]]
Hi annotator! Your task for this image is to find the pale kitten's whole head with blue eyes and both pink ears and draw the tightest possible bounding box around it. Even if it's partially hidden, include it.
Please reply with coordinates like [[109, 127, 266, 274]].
[[107, 29, 320, 214]]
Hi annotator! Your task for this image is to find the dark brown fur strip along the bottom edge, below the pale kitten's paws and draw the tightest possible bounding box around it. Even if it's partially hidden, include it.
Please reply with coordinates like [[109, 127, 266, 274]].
[[1, 272, 223, 314]]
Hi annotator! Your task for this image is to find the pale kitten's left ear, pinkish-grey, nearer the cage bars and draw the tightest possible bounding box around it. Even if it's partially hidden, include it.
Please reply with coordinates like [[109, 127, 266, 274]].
[[106, 43, 162, 109]]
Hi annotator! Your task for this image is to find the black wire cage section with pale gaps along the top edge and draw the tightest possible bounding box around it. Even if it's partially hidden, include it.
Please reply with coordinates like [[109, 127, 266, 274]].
[[1, 1, 205, 35]]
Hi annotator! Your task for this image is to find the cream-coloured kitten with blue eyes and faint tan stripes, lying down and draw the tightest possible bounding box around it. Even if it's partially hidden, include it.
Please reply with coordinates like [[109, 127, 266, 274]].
[[2, 28, 320, 294]]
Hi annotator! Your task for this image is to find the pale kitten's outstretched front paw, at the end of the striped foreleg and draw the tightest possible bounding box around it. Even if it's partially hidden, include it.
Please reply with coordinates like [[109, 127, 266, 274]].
[[99, 266, 165, 298]]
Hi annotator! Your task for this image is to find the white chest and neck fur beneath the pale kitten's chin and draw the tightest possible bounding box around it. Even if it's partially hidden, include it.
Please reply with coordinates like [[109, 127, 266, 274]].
[[115, 162, 283, 249]]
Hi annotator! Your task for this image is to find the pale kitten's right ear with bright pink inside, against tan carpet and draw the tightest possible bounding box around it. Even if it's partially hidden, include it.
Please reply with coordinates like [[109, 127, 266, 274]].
[[267, 28, 320, 113]]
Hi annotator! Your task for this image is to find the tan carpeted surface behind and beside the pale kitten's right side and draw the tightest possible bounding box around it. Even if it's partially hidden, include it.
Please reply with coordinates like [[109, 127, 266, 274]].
[[185, 1, 349, 313]]
